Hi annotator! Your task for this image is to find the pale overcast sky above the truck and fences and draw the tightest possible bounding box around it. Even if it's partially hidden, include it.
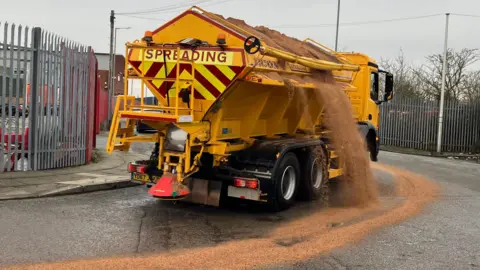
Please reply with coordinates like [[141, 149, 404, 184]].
[[0, 0, 480, 67]]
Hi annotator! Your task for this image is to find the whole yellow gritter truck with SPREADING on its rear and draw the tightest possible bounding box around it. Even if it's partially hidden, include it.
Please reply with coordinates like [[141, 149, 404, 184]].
[[107, 7, 393, 210]]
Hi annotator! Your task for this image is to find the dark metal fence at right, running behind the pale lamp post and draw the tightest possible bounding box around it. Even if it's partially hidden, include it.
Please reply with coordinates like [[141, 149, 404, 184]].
[[380, 97, 480, 154]]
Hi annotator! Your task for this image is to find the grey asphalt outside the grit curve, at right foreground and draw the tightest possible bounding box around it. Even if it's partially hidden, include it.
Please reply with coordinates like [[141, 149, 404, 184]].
[[275, 152, 480, 270]]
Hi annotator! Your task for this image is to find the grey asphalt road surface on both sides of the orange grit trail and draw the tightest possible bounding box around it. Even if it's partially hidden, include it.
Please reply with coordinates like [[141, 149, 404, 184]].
[[0, 152, 480, 269]]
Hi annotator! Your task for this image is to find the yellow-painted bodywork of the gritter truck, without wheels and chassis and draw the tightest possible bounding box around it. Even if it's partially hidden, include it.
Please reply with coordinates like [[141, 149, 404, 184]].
[[107, 8, 384, 181]]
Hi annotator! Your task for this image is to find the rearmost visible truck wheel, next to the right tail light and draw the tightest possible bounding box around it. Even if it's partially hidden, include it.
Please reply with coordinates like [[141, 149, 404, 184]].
[[272, 153, 300, 210]]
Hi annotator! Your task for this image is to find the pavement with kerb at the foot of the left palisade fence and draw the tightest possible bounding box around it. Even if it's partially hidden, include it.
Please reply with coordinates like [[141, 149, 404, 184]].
[[0, 133, 147, 200]]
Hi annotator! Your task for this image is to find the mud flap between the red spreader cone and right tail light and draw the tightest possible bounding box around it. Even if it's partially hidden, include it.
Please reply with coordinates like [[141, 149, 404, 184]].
[[184, 178, 222, 207]]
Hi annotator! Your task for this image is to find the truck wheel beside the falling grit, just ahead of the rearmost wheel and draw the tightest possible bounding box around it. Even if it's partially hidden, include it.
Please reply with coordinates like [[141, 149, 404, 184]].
[[301, 147, 329, 206]]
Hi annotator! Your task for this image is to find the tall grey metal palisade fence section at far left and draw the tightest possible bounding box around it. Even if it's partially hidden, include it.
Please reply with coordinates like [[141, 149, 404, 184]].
[[0, 23, 96, 172]]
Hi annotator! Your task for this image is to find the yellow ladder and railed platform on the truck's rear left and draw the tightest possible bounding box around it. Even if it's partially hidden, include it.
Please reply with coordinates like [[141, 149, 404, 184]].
[[107, 44, 195, 154]]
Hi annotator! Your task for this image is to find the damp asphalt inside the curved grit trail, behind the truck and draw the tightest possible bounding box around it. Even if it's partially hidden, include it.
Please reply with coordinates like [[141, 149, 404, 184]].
[[0, 169, 394, 265]]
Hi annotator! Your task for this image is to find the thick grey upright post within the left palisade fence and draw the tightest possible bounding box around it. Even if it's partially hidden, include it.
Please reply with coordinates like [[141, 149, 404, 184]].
[[28, 27, 42, 171]]
